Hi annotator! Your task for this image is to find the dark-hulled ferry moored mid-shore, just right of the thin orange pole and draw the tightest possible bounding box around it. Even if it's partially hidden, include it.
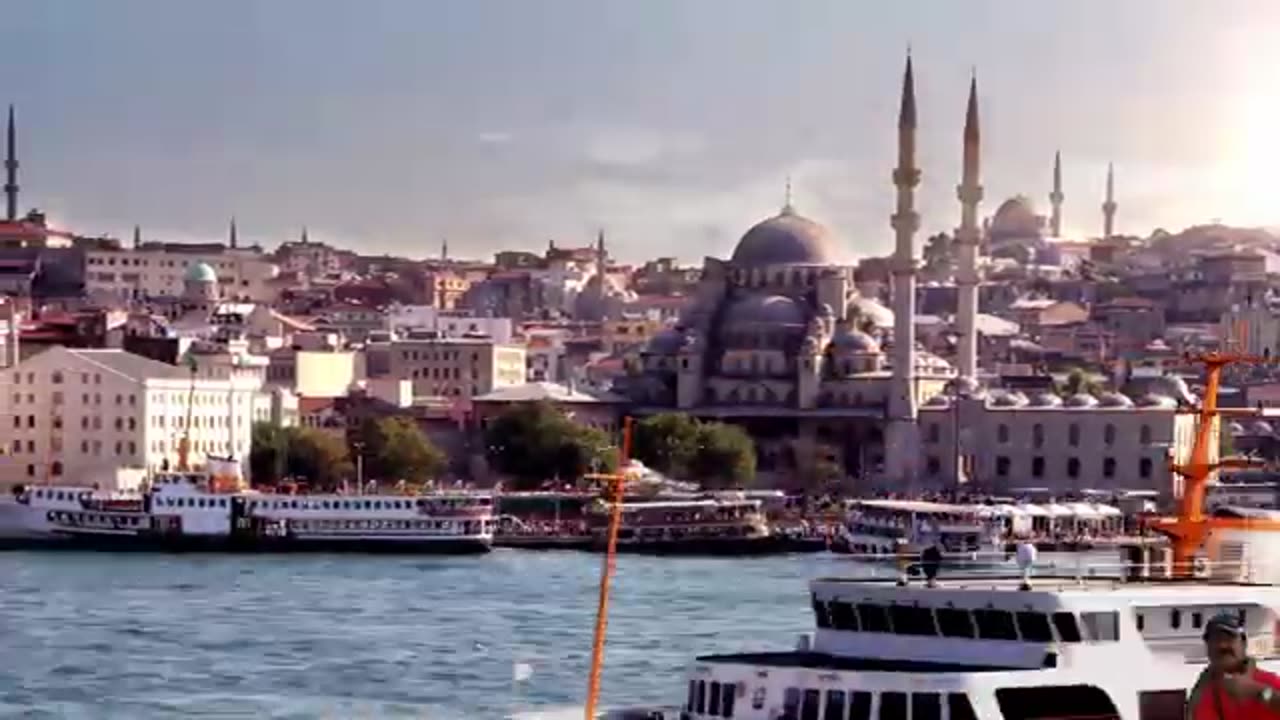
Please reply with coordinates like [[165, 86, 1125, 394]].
[[590, 497, 826, 555]]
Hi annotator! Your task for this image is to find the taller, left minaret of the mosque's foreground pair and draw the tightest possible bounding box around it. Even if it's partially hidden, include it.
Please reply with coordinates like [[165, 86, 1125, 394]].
[[884, 54, 920, 488]]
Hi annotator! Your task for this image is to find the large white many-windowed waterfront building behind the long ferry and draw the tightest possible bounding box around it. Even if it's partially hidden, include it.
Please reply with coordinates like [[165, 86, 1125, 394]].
[[0, 347, 270, 489]]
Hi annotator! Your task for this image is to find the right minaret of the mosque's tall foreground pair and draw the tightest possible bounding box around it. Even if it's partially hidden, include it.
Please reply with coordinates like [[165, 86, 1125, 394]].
[[956, 76, 982, 379]]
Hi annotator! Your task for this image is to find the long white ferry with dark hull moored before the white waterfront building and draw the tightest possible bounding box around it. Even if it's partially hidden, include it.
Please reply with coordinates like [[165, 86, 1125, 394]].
[[0, 473, 495, 553]]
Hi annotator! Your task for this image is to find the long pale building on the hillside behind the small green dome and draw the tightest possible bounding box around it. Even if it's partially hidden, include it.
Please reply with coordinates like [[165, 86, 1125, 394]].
[[84, 243, 279, 302]]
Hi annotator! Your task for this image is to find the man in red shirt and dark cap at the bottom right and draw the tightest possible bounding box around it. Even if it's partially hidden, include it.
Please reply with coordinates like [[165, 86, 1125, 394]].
[[1187, 612, 1280, 720]]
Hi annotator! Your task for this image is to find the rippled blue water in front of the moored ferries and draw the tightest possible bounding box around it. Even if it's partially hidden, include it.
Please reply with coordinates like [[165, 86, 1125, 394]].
[[0, 551, 858, 720]]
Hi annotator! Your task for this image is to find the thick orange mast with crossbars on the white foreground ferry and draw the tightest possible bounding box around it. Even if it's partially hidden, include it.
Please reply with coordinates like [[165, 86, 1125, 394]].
[[1152, 327, 1280, 578]]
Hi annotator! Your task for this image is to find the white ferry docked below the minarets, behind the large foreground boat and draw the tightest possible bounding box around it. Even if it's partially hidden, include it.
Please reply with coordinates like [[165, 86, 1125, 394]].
[[838, 500, 1004, 559]]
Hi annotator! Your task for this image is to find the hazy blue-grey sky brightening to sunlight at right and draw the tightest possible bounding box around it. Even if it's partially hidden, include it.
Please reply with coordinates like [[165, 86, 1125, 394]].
[[0, 0, 1280, 263]]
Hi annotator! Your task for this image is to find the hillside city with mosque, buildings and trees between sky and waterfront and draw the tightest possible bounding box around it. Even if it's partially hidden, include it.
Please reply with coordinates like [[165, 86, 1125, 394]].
[[0, 61, 1280, 496]]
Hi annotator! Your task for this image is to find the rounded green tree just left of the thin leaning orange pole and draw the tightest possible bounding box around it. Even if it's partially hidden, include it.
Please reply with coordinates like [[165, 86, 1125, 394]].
[[485, 402, 617, 488]]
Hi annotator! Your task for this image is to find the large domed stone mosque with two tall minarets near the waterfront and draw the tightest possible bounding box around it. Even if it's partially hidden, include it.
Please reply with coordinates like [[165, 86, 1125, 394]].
[[617, 59, 1194, 492]]
